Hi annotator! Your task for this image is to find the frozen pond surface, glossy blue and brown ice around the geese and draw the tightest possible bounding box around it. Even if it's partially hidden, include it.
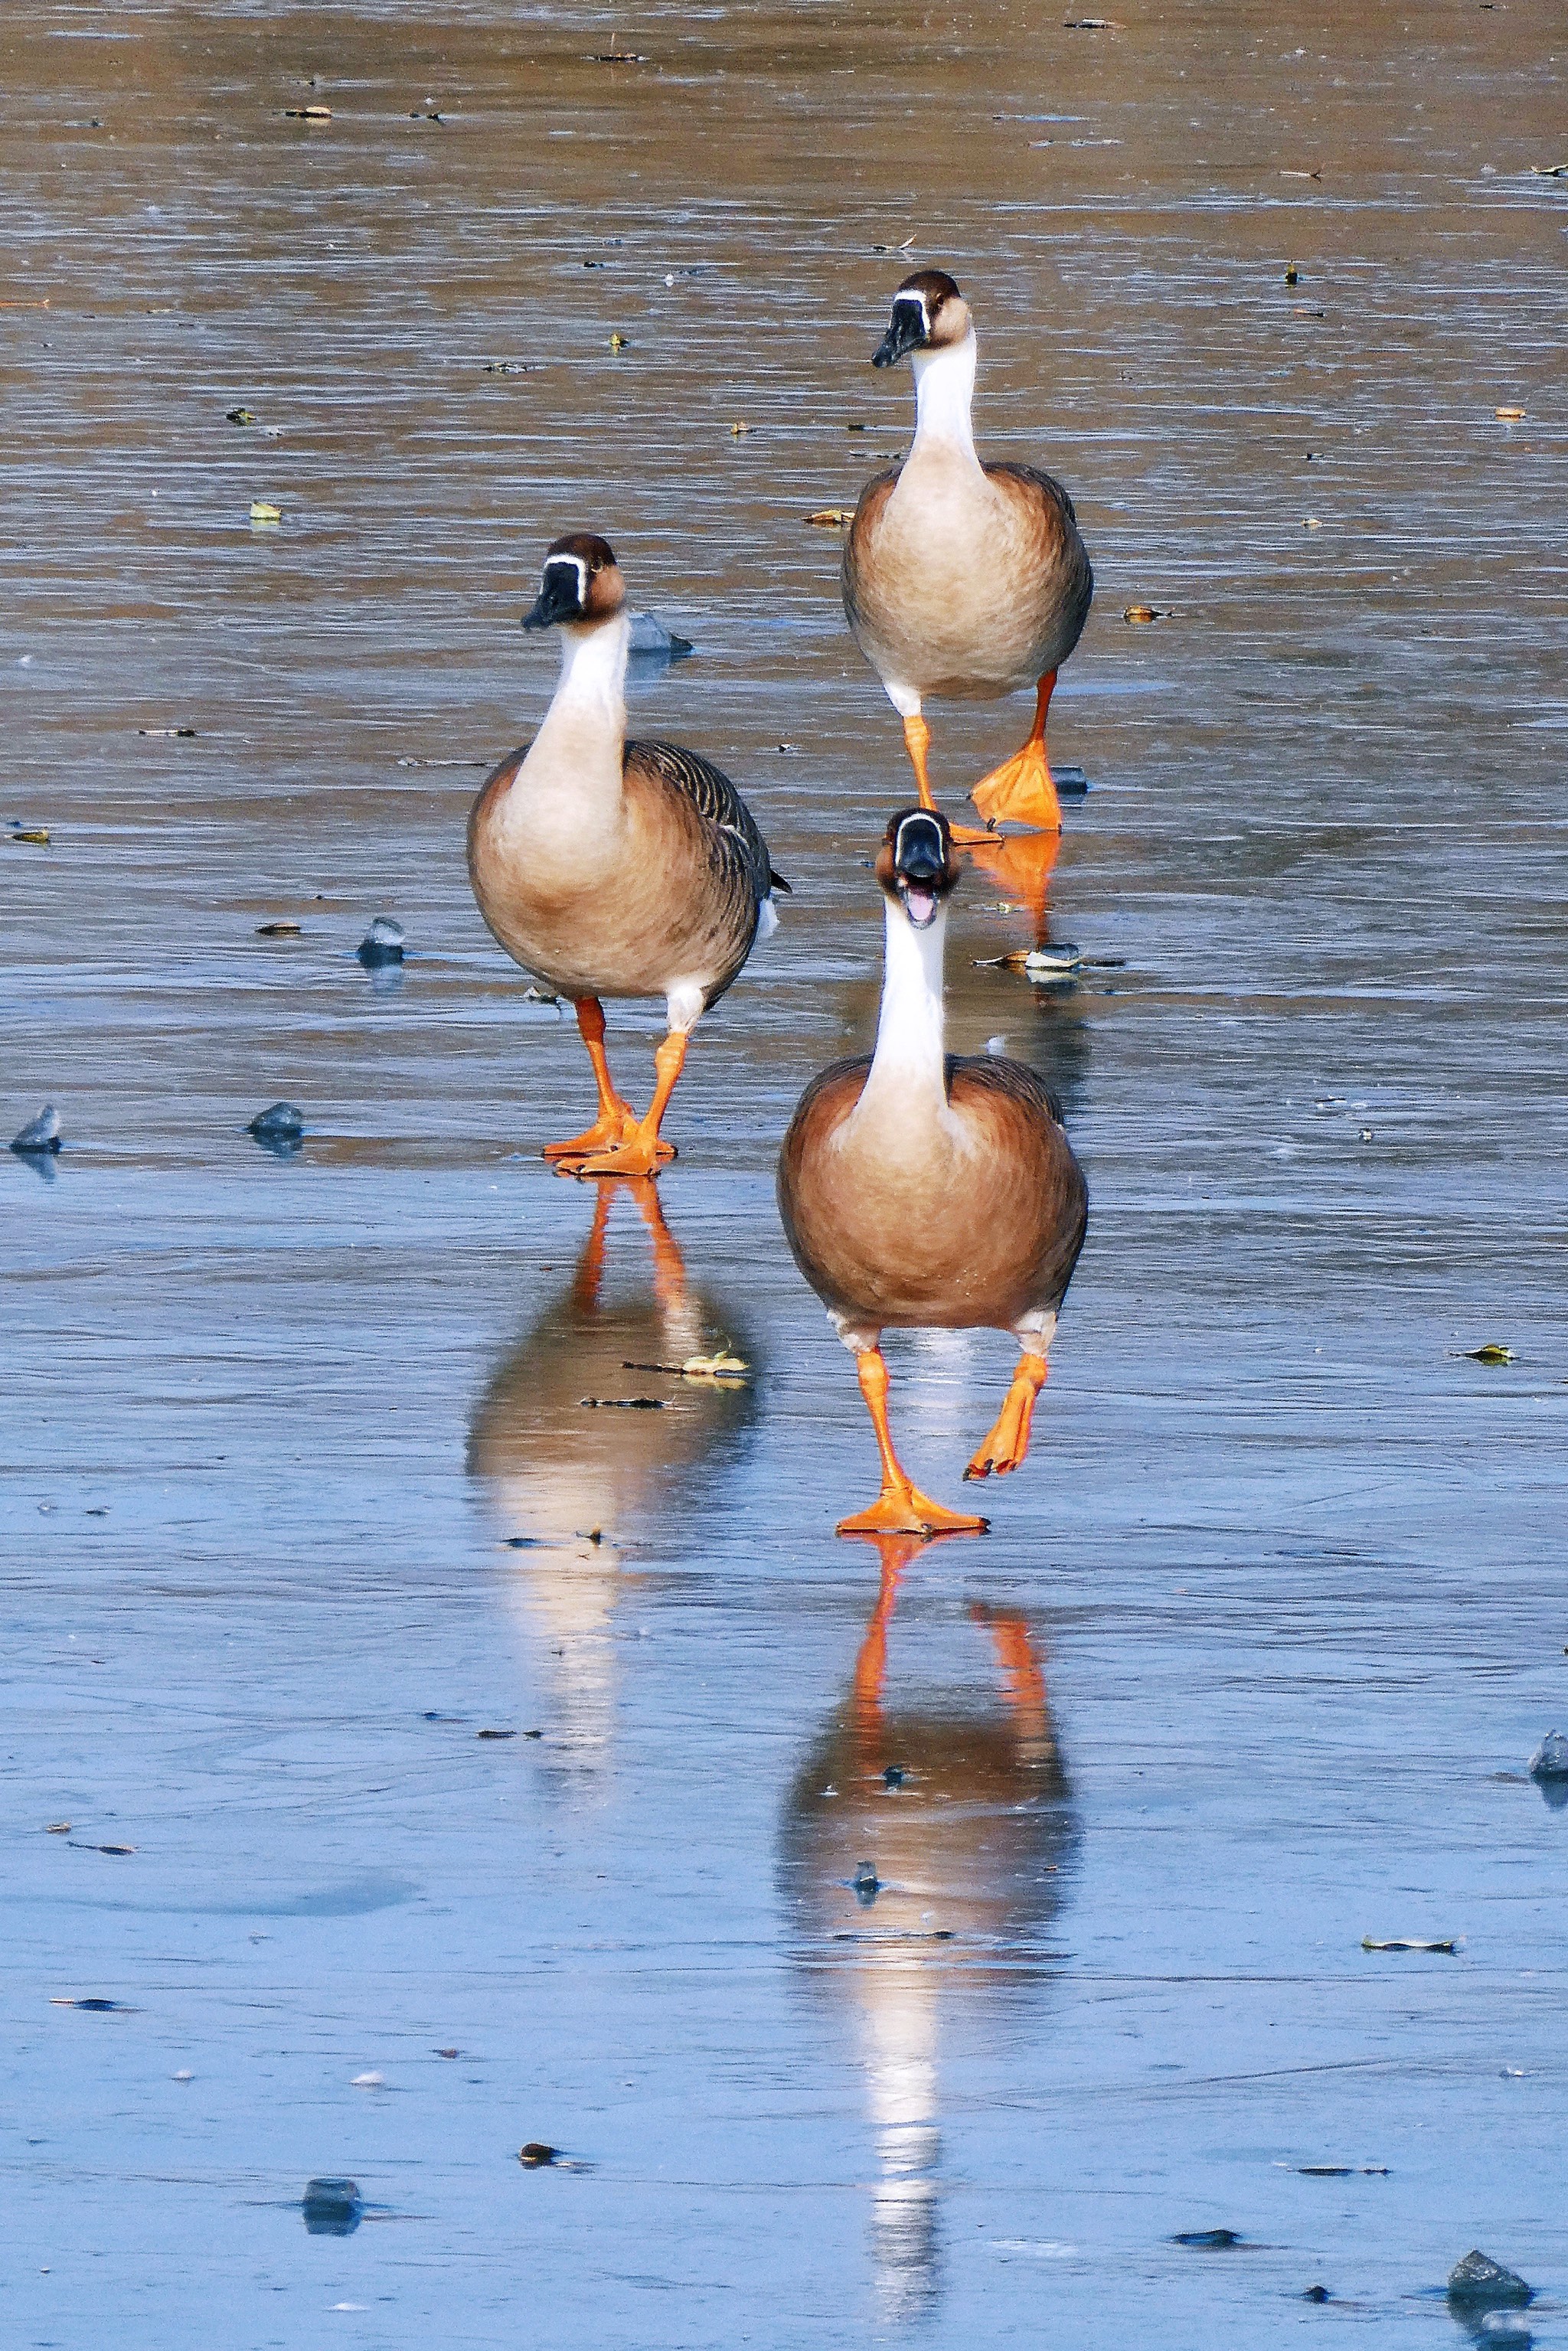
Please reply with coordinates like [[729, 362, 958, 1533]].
[[0, 0, 1568, 2351]]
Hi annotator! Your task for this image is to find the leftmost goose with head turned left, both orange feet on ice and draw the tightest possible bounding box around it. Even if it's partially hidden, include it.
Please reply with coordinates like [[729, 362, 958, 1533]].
[[468, 531, 790, 1178]]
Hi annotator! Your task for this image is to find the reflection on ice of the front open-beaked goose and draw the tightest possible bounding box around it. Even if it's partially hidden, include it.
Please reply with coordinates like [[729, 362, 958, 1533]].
[[782, 1535, 1079, 2325]]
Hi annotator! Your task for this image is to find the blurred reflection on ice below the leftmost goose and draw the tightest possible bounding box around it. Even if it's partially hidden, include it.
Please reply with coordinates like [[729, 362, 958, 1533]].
[[468, 1183, 755, 1775]]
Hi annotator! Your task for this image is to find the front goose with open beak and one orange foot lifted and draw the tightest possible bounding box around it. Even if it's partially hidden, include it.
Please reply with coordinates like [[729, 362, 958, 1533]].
[[778, 808, 1089, 1535]]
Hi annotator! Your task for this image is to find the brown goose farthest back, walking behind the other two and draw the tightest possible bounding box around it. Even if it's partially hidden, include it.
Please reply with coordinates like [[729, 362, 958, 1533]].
[[844, 270, 1093, 841]]
